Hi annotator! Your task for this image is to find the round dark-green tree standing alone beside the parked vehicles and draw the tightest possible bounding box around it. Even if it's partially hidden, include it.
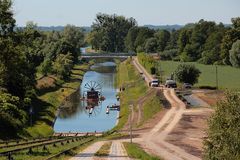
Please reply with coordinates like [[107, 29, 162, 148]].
[[175, 64, 201, 85]]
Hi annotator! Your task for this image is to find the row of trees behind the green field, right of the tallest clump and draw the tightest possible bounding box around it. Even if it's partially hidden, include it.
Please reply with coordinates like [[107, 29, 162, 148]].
[[130, 18, 240, 67]]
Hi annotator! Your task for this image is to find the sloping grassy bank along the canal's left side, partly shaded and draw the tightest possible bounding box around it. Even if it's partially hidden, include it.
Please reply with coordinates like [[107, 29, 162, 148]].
[[20, 64, 89, 137]]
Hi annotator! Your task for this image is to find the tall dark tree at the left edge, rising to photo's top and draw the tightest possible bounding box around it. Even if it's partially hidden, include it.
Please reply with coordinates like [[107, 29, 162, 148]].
[[0, 0, 35, 100]]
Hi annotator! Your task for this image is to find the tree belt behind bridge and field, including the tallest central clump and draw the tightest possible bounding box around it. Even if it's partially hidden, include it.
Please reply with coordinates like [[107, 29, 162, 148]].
[[87, 14, 240, 67]]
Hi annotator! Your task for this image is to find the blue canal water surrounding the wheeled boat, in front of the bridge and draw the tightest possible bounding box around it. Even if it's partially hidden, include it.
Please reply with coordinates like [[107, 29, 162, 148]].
[[54, 62, 119, 132]]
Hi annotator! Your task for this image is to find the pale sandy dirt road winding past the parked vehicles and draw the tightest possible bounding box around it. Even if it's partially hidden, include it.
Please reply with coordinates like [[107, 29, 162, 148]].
[[133, 58, 204, 160]]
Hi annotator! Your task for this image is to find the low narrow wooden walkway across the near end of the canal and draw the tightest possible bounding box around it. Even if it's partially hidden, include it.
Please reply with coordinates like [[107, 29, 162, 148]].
[[53, 132, 104, 137]]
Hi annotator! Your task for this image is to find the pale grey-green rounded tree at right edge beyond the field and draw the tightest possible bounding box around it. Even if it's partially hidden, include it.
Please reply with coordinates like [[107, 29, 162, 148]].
[[229, 40, 240, 67]]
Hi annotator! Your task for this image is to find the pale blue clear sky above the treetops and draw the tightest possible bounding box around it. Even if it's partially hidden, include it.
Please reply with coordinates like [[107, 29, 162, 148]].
[[13, 0, 240, 26]]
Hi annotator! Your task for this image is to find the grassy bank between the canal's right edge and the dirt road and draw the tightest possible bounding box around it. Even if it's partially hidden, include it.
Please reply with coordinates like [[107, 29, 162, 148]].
[[114, 60, 147, 129]]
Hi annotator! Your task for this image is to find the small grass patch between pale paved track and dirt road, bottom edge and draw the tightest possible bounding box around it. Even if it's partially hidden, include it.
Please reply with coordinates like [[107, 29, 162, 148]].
[[123, 142, 160, 160]]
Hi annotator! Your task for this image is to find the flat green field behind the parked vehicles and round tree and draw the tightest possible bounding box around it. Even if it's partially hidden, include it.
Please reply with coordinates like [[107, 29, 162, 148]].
[[160, 61, 240, 89]]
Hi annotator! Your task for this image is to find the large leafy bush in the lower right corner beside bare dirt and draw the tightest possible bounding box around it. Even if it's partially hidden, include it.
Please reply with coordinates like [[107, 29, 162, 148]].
[[204, 92, 240, 160]]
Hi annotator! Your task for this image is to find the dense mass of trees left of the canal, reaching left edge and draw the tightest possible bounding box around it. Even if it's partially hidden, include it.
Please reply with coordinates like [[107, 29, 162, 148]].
[[0, 0, 84, 138]]
